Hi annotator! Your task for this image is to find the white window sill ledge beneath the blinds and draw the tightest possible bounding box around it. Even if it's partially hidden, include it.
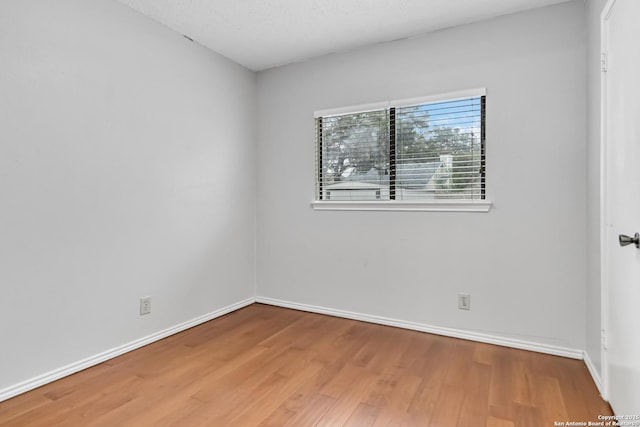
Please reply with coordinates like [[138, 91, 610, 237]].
[[311, 200, 491, 212]]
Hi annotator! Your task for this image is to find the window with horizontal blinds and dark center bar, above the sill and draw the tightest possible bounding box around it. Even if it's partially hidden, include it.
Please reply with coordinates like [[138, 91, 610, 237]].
[[314, 90, 485, 212]]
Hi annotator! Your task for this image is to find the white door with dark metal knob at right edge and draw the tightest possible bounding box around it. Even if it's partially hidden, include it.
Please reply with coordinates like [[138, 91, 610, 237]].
[[602, 0, 640, 418]]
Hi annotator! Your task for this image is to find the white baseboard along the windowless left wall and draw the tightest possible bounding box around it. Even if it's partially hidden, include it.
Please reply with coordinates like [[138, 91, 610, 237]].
[[0, 298, 255, 402]]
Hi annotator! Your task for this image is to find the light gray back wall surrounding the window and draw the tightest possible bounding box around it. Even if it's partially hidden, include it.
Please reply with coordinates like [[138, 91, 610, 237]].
[[257, 1, 586, 349]]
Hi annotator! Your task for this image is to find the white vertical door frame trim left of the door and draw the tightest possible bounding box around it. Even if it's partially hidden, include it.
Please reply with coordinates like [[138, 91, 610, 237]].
[[600, 0, 616, 401]]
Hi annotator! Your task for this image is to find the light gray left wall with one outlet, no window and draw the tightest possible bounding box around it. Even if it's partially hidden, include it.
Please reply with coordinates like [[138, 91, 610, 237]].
[[0, 0, 256, 391]]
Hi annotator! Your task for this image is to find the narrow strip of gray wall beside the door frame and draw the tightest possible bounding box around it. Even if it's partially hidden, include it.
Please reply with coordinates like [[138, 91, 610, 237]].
[[585, 0, 606, 382]]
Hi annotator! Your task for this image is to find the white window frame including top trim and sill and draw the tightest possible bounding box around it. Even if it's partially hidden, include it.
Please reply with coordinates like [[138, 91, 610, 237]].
[[311, 88, 492, 212]]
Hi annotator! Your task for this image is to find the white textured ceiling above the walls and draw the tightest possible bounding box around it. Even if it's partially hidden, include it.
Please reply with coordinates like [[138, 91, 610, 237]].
[[118, 0, 567, 71]]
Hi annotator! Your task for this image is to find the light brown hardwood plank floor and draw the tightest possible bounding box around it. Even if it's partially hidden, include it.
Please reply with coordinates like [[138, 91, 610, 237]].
[[0, 304, 611, 427]]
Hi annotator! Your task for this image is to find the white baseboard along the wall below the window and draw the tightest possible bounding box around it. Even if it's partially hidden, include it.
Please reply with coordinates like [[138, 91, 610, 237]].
[[256, 297, 584, 359]]
